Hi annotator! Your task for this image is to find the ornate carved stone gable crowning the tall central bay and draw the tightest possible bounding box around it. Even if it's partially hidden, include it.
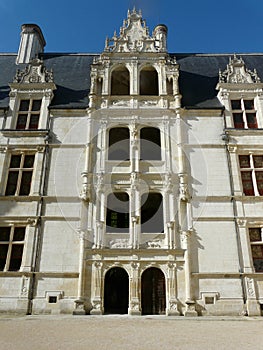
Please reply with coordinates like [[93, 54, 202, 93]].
[[104, 8, 167, 52]]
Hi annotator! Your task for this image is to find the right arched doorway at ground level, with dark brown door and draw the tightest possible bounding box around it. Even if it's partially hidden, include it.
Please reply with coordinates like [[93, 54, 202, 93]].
[[142, 267, 166, 315]]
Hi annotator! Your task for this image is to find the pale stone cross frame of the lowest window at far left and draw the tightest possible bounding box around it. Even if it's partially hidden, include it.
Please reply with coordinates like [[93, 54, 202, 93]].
[[0, 225, 26, 272]]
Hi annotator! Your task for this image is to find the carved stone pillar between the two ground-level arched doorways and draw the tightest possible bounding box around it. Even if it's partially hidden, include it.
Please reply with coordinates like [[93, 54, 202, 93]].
[[128, 262, 141, 315]]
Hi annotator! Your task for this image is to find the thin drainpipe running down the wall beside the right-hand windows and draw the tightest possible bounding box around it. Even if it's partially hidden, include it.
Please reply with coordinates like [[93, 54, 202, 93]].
[[222, 112, 248, 316]]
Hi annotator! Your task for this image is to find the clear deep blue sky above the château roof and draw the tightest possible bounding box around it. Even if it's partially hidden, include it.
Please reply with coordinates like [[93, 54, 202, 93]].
[[0, 0, 263, 53]]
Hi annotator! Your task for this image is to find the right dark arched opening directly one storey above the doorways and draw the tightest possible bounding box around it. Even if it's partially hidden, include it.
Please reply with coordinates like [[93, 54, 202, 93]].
[[141, 193, 164, 233]]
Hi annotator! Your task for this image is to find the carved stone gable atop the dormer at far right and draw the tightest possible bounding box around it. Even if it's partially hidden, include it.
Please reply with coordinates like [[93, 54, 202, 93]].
[[219, 55, 260, 84]]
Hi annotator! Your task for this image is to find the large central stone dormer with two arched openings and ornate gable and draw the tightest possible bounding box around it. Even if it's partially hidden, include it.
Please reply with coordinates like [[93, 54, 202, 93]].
[[89, 9, 181, 109]]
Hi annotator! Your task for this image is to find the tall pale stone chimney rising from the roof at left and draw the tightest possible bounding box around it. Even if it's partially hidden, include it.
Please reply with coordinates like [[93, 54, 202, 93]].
[[16, 24, 46, 64]]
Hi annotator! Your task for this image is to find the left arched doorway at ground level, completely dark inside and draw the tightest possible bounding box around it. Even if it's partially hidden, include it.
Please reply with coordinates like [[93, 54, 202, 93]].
[[104, 267, 129, 314]]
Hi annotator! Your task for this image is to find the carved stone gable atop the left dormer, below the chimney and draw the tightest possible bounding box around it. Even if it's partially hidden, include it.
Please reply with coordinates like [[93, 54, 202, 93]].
[[13, 58, 54, 84]]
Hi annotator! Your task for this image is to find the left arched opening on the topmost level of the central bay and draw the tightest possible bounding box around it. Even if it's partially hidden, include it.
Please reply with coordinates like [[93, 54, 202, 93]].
[[111, 66, 130, 95]]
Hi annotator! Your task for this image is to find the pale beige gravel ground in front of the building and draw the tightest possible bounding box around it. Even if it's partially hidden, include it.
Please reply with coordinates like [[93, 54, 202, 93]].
[[0, 315, 263, 350]]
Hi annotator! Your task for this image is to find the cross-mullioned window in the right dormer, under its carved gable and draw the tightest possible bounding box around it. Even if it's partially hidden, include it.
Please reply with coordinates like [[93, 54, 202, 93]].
[[231, 99, 258, 129]]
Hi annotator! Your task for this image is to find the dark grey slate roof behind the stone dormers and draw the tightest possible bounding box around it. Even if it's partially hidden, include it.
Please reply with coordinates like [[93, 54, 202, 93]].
[[0, 53, 263, 109]]
